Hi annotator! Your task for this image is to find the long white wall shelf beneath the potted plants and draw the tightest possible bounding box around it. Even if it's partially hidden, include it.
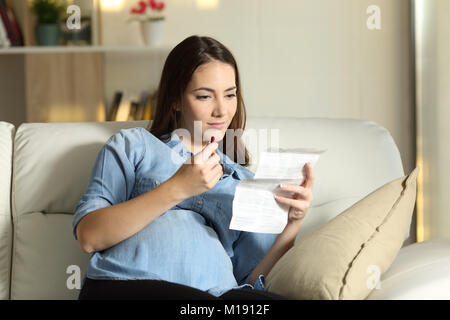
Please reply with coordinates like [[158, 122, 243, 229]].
[[0, 46, 169, 55]]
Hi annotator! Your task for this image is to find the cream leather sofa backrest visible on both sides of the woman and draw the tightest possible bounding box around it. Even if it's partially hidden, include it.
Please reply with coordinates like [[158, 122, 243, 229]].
[[10, 117, 404, 299]]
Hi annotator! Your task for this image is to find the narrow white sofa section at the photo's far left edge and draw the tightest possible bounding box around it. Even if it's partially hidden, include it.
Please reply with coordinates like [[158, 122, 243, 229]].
[[0, 121, 15, 300]]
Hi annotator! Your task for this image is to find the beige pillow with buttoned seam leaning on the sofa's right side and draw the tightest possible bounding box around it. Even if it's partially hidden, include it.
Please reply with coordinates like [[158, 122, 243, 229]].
[[266, 168, 419, 300]]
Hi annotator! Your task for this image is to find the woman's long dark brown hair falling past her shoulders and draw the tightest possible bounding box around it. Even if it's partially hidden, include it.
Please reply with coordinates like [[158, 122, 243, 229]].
[[147, 35, 250, 166]]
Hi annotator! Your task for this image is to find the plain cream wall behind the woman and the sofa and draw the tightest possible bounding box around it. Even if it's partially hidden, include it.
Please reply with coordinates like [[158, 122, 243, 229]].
[[105, 0, 415, 172]]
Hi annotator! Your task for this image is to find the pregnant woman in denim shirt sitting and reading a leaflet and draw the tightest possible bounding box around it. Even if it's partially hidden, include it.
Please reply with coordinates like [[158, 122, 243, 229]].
[[73, 36, 314, 299]]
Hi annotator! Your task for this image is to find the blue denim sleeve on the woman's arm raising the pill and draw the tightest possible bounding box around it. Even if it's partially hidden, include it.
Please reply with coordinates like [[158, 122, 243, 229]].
[[72, 130, 145, 239]]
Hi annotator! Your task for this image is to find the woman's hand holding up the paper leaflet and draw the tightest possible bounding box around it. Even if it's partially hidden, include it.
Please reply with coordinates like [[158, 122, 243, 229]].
[[275, 163, 314, 225]]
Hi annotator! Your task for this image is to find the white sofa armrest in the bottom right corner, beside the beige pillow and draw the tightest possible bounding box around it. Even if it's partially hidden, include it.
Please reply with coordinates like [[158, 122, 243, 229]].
[[367, 239, 450, 300]]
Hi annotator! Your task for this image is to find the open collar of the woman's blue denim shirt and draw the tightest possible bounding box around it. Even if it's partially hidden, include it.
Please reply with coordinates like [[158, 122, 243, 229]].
[[161, 131, 245, 180]]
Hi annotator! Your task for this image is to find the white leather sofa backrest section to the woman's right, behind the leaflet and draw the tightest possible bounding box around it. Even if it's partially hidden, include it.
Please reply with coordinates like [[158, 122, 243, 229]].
[[246, 117, 409, 241]]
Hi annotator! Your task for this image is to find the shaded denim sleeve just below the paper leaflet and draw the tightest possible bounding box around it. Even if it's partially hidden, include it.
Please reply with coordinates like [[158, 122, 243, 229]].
[[231, 231, 278, 290]]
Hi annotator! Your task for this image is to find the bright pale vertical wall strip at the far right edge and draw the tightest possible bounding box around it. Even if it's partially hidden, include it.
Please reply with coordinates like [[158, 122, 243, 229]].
[[415, 0, 450, 241]]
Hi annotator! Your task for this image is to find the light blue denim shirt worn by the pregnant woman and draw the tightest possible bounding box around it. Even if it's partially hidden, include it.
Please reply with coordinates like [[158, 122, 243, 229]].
[[72, 128, 277, 296]]
